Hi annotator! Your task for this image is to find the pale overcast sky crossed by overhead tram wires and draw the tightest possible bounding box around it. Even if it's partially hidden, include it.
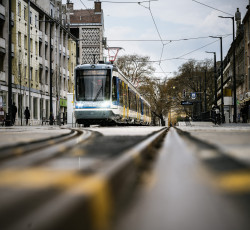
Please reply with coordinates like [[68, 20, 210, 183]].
[[63, 0, 249, 77]]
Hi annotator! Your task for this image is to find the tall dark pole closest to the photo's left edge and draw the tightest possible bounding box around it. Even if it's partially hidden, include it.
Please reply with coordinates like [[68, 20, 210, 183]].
[[8, 1, 12, 126]]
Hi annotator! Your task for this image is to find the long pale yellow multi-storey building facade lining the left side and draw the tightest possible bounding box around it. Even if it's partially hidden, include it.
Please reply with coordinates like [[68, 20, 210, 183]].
[[0, 0, 76, 124]]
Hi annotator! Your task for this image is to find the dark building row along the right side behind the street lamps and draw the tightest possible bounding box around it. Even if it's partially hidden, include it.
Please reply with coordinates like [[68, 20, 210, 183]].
[[218, 6, 246, 123]]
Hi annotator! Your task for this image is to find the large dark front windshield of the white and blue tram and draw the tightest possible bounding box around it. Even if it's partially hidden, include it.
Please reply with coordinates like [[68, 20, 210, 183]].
[[76, 69, 110, 101]]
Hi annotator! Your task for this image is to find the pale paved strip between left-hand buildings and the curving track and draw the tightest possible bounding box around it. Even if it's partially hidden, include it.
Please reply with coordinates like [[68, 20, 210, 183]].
[[0, 125, 70, 148]]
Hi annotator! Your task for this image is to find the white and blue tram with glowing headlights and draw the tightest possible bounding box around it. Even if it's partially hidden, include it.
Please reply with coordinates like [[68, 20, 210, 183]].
[[74, 64, 151, 127]]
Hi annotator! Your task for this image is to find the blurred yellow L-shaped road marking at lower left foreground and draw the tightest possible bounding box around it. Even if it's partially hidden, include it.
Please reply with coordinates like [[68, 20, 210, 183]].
[[0, 168, 112, 230]]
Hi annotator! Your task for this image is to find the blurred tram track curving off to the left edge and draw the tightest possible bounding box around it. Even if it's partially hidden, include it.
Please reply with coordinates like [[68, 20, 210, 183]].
[[0, 129, 91, 169]]
